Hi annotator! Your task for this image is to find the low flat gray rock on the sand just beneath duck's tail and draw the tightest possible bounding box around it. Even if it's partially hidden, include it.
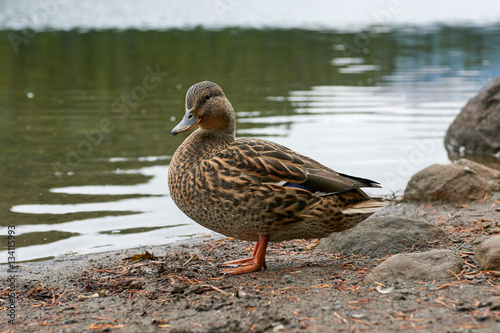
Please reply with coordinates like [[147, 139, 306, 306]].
[[319, 215, 448, 256]]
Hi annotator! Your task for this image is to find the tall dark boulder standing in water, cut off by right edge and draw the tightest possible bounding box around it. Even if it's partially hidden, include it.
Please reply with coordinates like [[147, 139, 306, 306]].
[[444, 76, 500, 157]]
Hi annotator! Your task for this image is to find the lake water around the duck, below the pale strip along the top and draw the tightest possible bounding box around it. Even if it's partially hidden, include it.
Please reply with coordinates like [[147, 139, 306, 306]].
[[0, 8, 500, 262]]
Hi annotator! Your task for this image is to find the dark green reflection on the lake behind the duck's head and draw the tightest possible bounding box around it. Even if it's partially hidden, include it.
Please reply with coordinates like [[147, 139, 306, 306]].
[[0, 27, 498, 233]]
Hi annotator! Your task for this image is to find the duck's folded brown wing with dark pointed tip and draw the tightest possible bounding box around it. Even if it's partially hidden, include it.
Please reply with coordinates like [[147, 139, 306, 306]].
[[214, 139, 380, 193]]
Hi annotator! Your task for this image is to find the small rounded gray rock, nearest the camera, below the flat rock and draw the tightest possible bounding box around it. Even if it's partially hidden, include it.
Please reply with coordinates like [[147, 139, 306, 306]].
[[364, 250, 463, 283]]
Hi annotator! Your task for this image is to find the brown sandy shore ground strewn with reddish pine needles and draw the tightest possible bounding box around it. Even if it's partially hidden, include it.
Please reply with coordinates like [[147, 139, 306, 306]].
[[0, 198, 500, 332]]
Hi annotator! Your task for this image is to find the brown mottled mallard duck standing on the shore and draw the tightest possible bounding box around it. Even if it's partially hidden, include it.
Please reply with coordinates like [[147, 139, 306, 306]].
[[168, 81, 388, 274]]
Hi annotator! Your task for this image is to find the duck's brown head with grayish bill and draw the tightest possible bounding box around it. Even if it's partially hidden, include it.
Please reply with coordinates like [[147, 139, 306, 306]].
[[172, 81, 235, 135]]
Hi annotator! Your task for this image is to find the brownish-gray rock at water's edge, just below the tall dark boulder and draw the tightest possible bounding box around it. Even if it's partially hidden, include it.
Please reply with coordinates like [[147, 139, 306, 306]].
[[403, 160, 495, 203]]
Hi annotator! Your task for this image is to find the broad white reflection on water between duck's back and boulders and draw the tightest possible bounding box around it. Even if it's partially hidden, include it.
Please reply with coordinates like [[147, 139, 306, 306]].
[[250, 81, 474, 194]]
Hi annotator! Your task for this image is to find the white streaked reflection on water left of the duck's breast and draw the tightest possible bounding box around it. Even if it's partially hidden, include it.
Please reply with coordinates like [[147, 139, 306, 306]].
[[11, 163, 209, 260]]
